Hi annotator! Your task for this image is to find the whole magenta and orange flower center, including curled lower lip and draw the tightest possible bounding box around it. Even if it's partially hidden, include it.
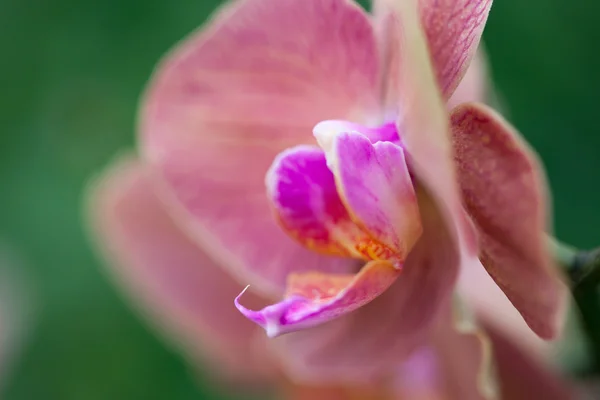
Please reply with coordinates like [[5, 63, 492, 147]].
[[236, 121, 422, 336]]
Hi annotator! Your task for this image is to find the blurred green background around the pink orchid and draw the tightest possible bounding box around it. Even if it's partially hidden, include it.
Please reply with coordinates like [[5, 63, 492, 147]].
[[0, 0, 600, 400]]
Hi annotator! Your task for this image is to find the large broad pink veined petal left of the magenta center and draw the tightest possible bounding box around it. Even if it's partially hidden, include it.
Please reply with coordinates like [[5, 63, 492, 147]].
[[140, 0, 379, 294]]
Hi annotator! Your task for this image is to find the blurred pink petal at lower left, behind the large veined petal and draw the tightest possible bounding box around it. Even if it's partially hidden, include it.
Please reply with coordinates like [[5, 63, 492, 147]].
[[88, 155, 272, 381]]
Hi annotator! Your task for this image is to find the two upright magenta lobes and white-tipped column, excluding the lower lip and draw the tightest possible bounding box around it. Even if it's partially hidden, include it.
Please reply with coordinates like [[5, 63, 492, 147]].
[[266, 121, 420, 265]]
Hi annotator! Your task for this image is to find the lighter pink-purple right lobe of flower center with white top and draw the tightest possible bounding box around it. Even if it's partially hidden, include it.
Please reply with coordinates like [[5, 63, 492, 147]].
[[315, 129, 422, 263]]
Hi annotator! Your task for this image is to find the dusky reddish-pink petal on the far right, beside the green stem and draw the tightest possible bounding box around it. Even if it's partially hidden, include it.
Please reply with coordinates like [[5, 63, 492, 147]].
[[452, 104, 566, 339]]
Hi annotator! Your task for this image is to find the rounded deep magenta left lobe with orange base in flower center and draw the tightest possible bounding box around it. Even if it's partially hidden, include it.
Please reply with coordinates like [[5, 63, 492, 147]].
[[266, 145, 368, 258]]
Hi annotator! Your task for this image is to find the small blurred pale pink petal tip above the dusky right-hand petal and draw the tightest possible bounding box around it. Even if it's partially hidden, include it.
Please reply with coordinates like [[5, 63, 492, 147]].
[[447, 46, 494, 110]]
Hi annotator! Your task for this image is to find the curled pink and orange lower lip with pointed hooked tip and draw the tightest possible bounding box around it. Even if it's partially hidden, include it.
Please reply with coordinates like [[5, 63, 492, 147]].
[[235, 261, 400, 337]]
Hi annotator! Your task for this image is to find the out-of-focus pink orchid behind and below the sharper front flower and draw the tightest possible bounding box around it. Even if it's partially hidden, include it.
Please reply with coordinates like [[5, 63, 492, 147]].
[[88, 156, 573, 400]]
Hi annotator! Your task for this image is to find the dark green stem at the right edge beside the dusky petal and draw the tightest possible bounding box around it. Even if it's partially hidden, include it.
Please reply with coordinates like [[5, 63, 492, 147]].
[[552, 240, 600, 374]]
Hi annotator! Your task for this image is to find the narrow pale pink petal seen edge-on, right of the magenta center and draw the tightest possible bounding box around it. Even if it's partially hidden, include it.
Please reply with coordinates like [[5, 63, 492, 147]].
[[375, 0, 477, 259]]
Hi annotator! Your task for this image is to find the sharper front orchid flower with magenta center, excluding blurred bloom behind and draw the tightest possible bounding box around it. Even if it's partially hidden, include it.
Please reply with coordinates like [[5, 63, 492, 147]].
[[140, 0, 564, 344]]
